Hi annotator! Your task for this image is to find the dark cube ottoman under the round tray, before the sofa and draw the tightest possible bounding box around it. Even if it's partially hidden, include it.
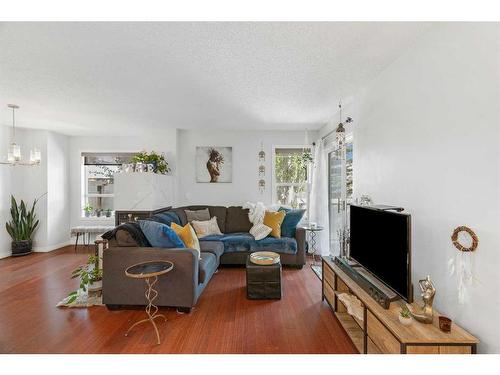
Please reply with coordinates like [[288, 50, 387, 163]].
[[246, 256, 281, 299]]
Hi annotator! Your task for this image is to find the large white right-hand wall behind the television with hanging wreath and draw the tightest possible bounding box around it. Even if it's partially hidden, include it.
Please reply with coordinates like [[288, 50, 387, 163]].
[[326, 23, 500, 353]]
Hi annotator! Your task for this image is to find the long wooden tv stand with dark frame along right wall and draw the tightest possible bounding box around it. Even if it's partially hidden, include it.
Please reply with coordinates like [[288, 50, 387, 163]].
[[322, 257, 479, 354]]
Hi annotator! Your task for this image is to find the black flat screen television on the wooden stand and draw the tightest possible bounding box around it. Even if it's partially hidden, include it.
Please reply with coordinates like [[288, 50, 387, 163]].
[[350, 205, 412, 302]]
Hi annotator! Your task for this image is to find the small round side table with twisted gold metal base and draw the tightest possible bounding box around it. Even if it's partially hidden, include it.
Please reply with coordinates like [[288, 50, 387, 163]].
[[125, 261, 174, 345]]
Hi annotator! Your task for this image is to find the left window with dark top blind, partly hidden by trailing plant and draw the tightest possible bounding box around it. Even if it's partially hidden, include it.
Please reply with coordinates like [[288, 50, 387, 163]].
[[82, 153, 134, 217]]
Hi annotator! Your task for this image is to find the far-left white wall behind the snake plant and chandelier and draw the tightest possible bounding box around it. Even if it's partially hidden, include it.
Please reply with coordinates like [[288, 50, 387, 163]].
[[0, 126, 69, 257]]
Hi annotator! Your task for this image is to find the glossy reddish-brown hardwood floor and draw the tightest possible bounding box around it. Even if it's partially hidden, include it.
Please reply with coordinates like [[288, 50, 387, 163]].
[[0, 246, 356, 354]]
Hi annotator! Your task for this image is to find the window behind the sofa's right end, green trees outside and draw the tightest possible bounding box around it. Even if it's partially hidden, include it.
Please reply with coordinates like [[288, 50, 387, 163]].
[[273, 147, 311, 209]]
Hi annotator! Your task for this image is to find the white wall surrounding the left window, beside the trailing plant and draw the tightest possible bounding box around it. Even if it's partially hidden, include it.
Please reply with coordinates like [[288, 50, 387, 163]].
[[69, 129, 177, 226]]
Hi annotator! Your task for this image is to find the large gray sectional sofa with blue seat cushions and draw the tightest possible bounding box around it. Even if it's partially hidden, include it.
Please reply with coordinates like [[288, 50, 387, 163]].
[[103, 206, 306, 312]]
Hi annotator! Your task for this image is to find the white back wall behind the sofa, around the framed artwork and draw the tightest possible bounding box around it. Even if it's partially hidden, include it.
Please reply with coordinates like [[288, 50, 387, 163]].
[[177, 130, 316, 205]]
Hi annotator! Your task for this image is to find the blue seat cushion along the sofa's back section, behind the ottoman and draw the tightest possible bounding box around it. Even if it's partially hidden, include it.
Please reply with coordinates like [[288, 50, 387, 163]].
[[203, 233, 297, 254]]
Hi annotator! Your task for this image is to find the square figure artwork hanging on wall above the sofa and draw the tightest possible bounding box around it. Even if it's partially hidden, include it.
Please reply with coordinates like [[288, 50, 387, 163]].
[[196, 146, 233, 183]]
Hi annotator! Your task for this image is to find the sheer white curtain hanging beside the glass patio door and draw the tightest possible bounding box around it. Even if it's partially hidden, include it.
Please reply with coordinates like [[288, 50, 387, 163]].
[[309, 139, 330, 255]]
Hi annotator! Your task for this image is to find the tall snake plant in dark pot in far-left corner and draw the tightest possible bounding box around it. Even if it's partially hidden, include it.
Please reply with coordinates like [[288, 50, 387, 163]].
[[5, 195, 39, 256]]
